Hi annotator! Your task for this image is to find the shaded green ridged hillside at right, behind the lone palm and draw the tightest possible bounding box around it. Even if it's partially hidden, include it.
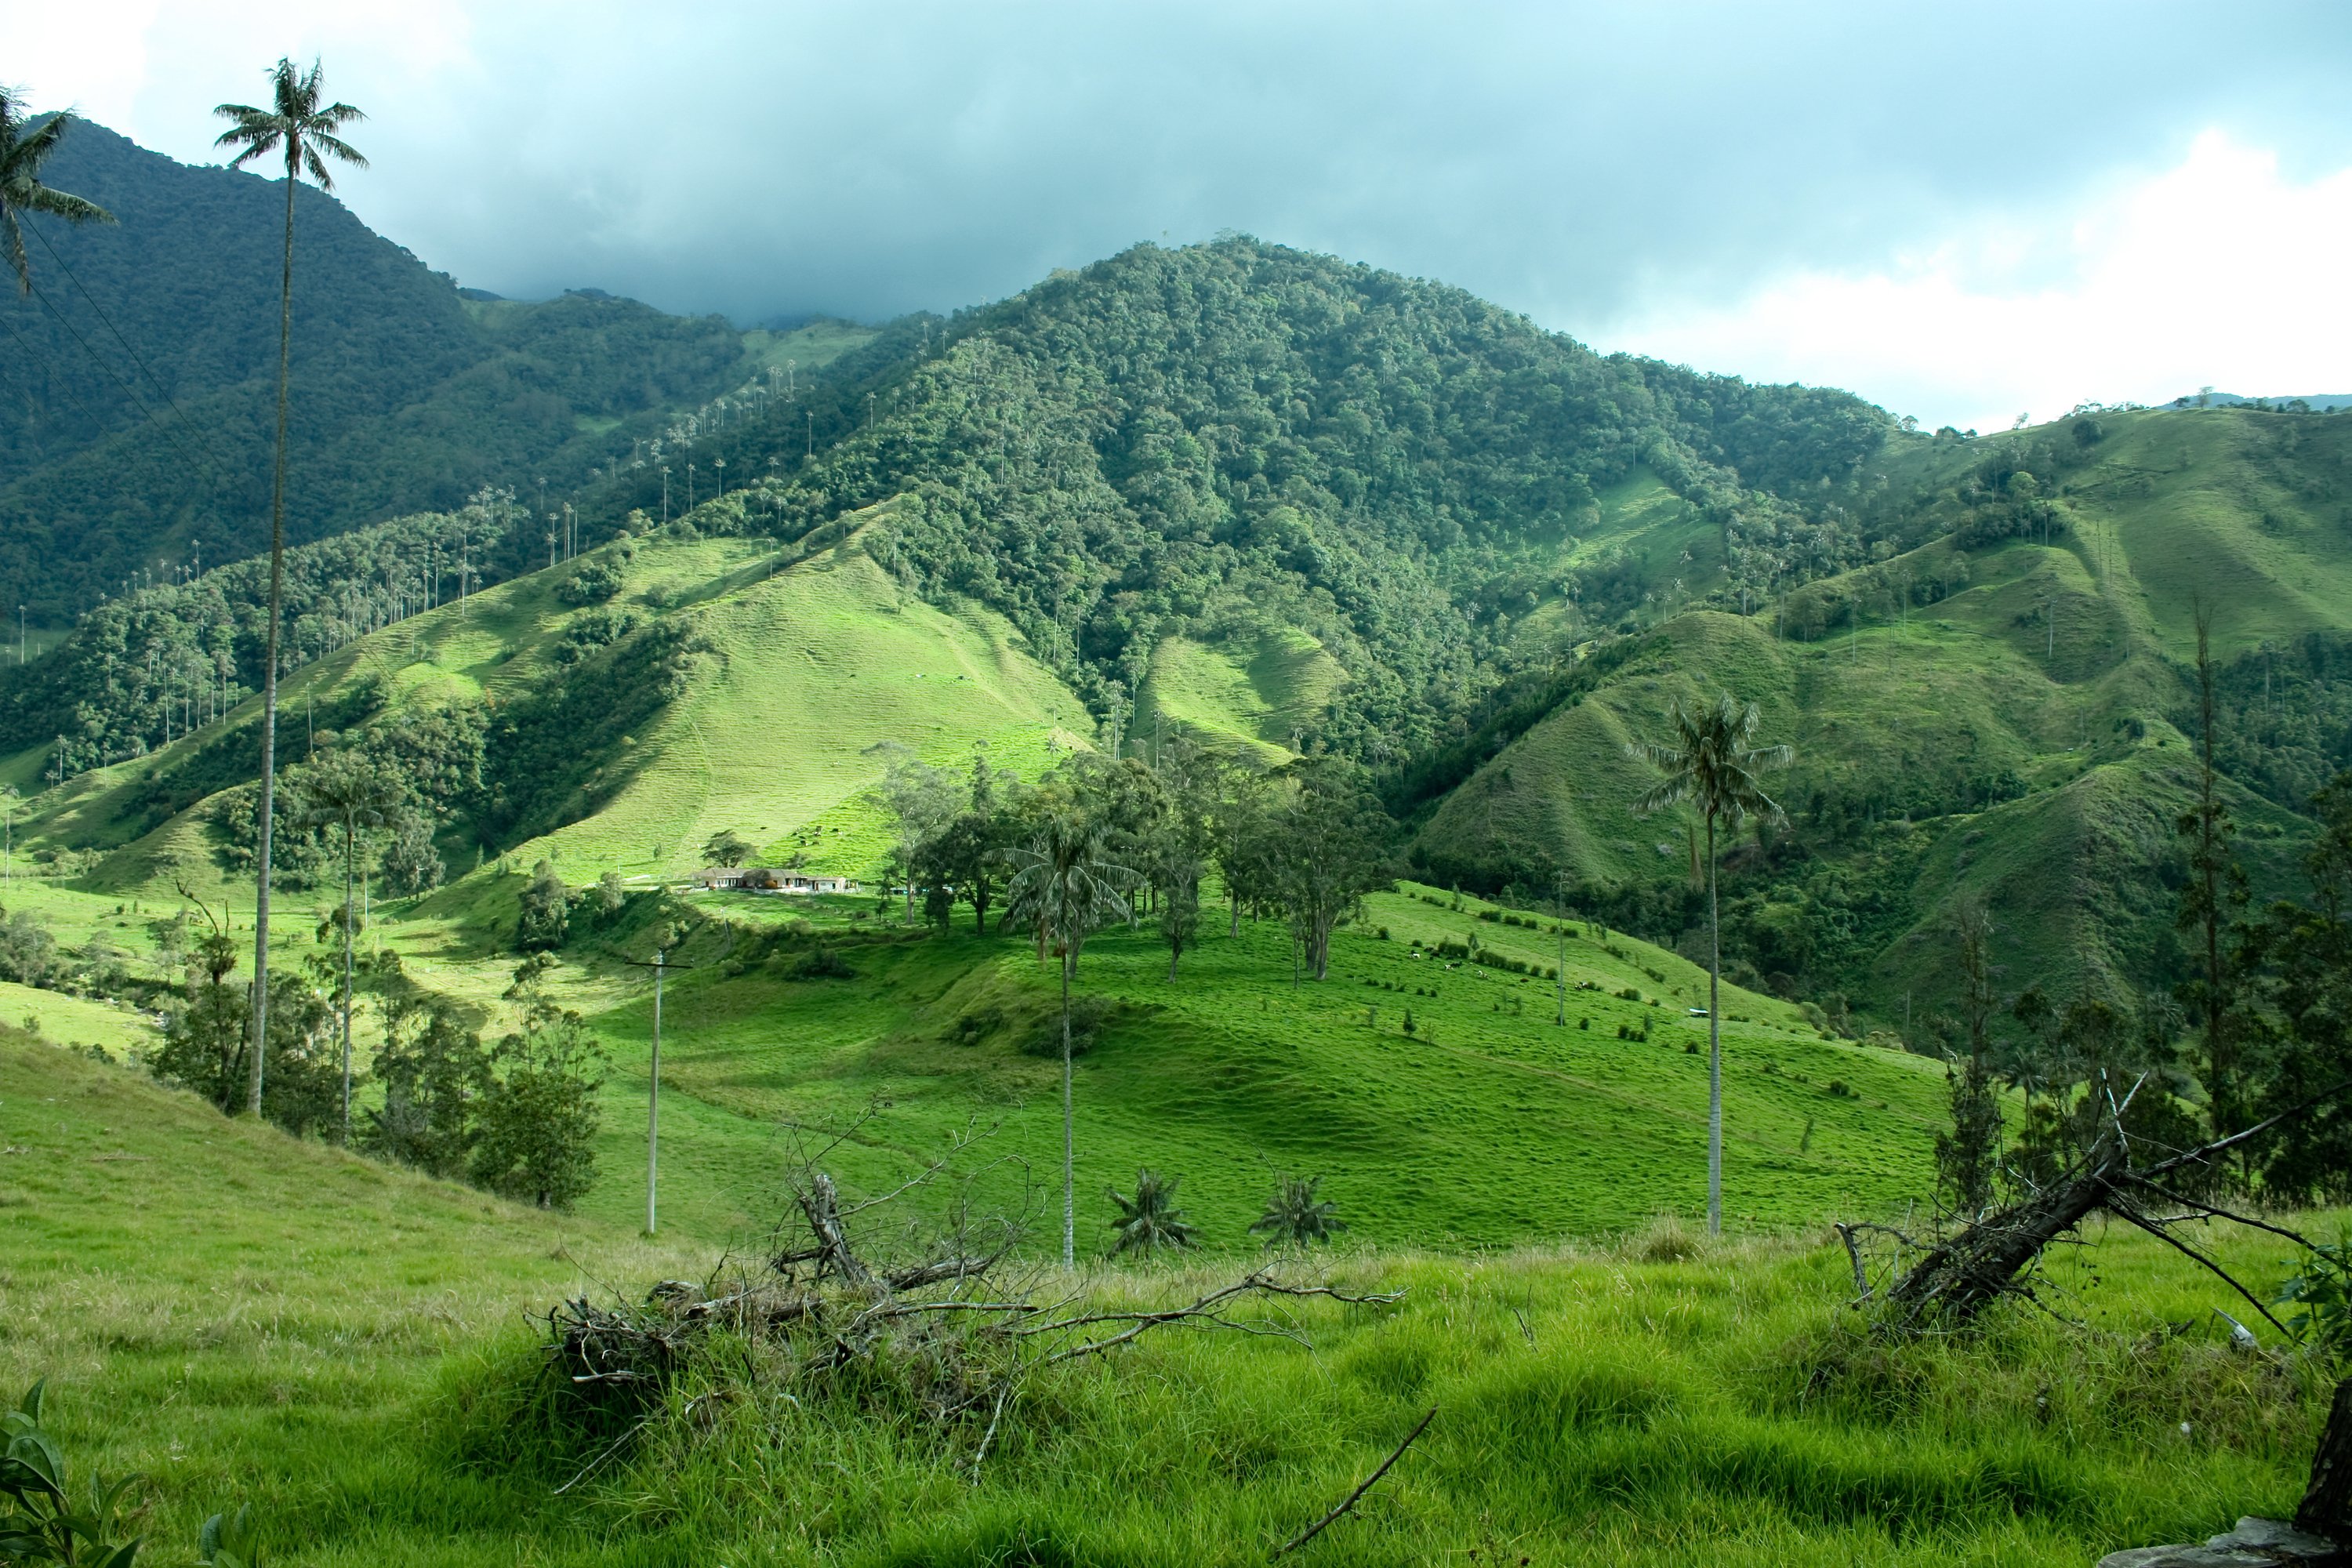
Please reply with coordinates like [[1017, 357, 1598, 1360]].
[[1414, 412, 2352, 1020]]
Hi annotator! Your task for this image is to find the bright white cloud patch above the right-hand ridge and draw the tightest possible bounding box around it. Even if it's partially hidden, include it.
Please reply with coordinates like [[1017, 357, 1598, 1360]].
[[1602, 132, 2352, 428]]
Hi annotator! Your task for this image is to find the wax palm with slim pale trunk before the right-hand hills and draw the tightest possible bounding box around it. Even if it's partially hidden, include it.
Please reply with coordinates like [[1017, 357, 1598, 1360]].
[[1625, 694, 1795, 1236]]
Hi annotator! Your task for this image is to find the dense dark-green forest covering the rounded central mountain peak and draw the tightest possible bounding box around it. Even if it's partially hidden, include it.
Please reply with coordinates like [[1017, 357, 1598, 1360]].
[[602, 238, 1896, 760]]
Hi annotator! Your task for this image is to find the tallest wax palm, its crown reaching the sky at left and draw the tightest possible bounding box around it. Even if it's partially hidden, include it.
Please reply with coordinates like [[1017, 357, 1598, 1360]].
[[212, 59, 367, 1116]]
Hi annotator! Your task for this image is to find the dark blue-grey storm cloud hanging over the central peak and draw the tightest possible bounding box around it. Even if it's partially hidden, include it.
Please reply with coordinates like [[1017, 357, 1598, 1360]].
[[353, 5, 2352, 332]]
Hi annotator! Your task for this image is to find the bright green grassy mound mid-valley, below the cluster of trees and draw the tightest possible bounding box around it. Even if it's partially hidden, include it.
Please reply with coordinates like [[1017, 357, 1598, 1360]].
[[550, 893, 1943, 1250]]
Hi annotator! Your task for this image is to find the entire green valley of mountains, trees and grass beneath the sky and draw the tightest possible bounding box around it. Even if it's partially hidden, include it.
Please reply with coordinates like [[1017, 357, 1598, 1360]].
[[0, 100, 2352, 1566]]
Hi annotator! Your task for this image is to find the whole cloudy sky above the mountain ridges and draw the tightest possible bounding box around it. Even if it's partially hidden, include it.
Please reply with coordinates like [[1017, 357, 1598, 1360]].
[[18, 0, 2352, 428]]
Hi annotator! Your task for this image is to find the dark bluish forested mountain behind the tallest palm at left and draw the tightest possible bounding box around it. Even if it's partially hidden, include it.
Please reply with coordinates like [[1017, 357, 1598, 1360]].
[[0, 122, 856, 626]]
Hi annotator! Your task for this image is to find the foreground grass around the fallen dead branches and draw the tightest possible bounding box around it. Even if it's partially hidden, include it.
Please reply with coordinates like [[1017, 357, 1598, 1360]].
[[0, 1032, 2319, 1568]]
